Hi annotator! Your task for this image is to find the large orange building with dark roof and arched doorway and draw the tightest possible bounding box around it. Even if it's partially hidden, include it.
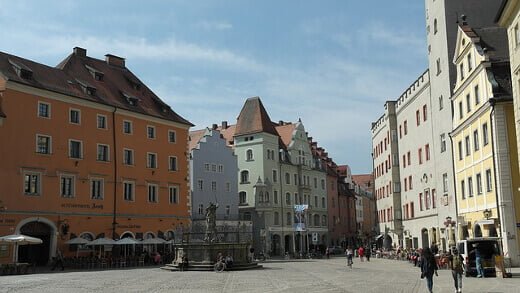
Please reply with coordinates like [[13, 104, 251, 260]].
[[0, 47, 192, 265]]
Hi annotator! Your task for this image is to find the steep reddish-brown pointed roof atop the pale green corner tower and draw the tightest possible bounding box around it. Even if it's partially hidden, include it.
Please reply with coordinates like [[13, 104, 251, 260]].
[[235, 97, 279, 136]]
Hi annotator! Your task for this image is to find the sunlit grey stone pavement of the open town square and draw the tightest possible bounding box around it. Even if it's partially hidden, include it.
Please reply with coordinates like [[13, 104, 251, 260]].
[[0, 257, 520, 293]]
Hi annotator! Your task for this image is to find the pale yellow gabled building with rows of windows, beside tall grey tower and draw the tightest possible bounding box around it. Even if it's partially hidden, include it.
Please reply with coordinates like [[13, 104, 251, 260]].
[[451, 22, 519, 263]]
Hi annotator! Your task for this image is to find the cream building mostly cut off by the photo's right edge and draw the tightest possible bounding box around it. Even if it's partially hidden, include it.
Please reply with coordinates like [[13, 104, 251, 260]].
[[497, 0, 520, 264]]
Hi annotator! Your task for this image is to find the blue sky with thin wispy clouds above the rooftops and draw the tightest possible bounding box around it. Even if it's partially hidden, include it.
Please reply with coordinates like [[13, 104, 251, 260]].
[[0, 0, 428, 174]]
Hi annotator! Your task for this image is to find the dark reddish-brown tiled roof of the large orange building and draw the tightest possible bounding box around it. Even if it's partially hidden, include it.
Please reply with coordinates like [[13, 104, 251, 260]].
[[0, 48, 193, 126]]
